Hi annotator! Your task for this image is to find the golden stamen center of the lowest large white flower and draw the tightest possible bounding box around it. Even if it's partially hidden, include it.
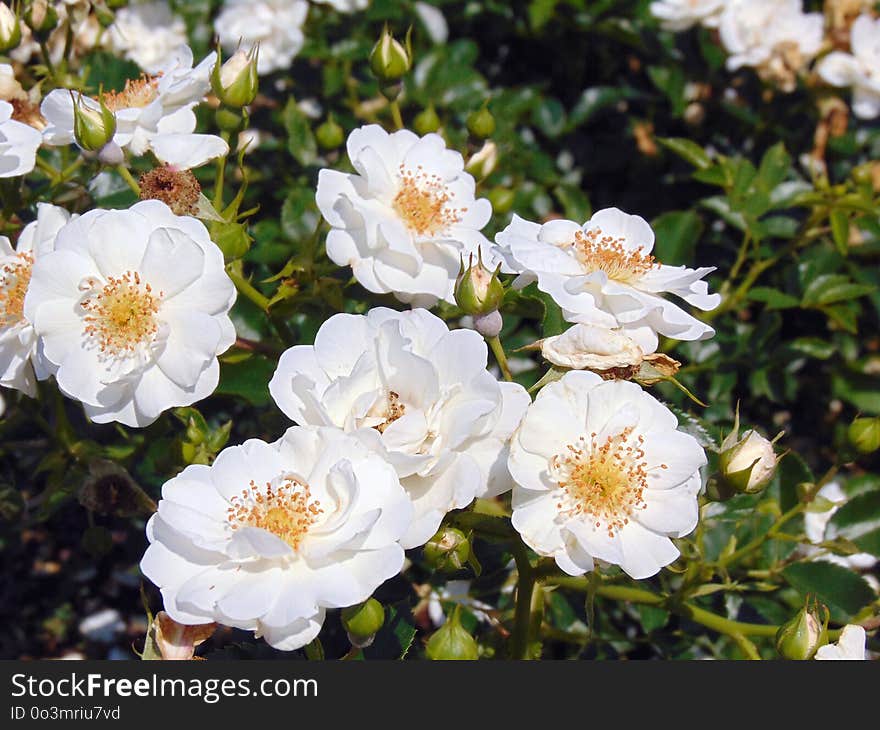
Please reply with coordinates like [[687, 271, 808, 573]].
[[226, 476, 324, 552]]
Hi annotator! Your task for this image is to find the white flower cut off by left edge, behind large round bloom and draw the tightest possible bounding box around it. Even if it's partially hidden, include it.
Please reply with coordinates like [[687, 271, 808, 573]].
[[0, 203, 76, 396]]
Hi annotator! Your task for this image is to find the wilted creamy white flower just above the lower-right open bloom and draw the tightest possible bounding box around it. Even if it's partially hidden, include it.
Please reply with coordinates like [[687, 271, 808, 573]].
[[540, 324, 645, 370]]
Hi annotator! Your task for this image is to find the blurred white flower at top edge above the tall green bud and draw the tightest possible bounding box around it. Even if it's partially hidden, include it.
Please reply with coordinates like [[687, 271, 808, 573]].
[[214, 0, 309, 74]]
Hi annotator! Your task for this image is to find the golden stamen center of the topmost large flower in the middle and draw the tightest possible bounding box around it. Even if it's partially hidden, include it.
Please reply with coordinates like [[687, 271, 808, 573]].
[[393, 165, 467, 236]]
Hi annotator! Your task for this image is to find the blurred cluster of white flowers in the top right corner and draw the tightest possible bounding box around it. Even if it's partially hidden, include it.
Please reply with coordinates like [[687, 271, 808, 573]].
[[650, 0, 880, 110]]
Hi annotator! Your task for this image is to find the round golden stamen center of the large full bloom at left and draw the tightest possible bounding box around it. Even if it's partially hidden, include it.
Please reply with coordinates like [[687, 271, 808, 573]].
[[80, 271, 162, 357]]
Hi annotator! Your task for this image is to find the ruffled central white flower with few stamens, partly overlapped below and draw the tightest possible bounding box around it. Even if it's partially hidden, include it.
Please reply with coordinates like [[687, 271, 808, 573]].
[[269, 308, 529, 548]]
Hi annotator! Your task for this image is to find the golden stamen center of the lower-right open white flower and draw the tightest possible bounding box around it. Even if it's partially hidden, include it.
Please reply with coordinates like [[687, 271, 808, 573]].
[[550, 428, 666, 537]]
